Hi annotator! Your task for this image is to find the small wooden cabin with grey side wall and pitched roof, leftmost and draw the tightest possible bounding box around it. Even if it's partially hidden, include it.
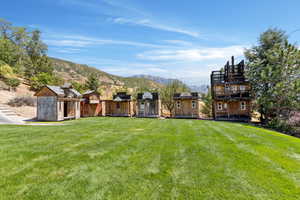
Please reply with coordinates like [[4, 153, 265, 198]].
[[35, 84, 81, 121]]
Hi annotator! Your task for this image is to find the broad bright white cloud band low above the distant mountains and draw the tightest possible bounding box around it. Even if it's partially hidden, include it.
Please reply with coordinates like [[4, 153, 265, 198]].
[[137, 45, 246, 61]]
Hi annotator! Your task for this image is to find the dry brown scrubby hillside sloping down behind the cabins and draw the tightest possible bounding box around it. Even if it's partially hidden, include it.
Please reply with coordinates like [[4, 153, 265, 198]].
[[50, 58, 163, 89]]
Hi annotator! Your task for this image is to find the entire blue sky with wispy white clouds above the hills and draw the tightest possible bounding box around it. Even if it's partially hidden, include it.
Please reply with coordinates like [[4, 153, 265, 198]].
[[0, 0, 300, 85]]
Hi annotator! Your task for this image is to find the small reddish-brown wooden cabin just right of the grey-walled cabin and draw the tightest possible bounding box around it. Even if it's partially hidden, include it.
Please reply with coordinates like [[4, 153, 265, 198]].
[[80, 91, 105, 117]]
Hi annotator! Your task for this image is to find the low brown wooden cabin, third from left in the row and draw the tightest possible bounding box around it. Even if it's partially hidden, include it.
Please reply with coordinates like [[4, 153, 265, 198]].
[[105, 92, 134, 117]]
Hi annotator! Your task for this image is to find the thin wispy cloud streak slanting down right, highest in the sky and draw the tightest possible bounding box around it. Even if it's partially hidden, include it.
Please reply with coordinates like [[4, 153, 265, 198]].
[[113, 17, 200, 38]]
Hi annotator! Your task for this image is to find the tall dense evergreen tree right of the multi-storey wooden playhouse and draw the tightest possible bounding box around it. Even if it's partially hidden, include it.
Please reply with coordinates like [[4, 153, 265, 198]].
[[245, 29, 300, 123]]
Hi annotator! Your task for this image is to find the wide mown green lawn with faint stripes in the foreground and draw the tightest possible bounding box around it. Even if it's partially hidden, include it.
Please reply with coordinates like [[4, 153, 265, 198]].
[[0, 118, 300, 200]]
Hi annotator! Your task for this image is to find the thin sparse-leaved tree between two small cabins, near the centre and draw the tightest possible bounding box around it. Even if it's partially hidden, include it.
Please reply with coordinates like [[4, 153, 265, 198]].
[[160, 80, 189, 115]]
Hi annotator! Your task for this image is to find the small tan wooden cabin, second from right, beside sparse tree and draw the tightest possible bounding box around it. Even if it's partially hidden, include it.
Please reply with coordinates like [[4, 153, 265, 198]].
[[173, 92, 201, 118]]
